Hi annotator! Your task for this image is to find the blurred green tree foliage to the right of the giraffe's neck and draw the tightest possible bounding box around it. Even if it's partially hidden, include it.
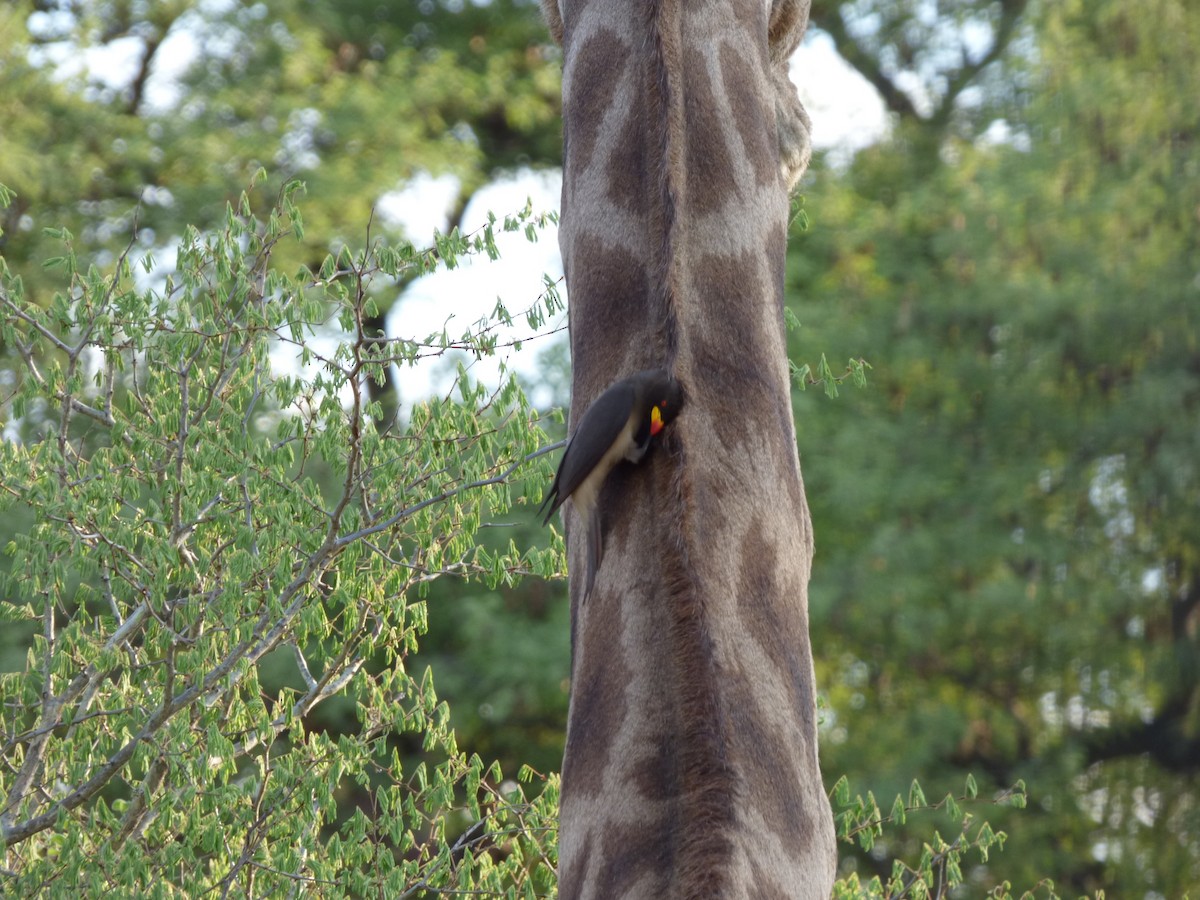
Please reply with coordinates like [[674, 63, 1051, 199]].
[[792, 2, 1200, 896]]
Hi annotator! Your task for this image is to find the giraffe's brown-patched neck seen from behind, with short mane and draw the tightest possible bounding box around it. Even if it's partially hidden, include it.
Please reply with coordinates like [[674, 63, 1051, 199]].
[[545, 0, 836, 900]]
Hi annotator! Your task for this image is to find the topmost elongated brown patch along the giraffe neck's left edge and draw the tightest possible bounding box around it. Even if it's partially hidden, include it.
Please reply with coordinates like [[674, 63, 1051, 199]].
[[563, 28, 629, 176]]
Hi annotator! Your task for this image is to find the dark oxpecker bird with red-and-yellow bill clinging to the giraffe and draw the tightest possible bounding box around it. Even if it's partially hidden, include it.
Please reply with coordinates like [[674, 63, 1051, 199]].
[[542, 368, 683, 596]]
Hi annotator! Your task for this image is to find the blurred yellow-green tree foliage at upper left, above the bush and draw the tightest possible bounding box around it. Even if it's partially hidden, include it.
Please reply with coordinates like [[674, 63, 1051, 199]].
[[0, 0, 562, 302]]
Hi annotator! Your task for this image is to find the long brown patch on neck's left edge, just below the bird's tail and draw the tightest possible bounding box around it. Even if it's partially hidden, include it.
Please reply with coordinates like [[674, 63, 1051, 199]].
[[563, 590, 632, 798]]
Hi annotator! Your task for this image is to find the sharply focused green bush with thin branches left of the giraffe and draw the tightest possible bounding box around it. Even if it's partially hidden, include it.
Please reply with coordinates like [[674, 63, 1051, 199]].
[[0, 185, 563, 896]]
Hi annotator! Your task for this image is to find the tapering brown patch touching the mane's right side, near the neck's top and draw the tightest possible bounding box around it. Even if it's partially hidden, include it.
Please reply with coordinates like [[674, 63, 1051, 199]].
[[683, 47, 737, 216]]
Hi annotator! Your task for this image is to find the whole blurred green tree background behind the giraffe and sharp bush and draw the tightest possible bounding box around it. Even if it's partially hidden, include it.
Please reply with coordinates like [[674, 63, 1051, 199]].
[[0, 0, 1200, 898]]
